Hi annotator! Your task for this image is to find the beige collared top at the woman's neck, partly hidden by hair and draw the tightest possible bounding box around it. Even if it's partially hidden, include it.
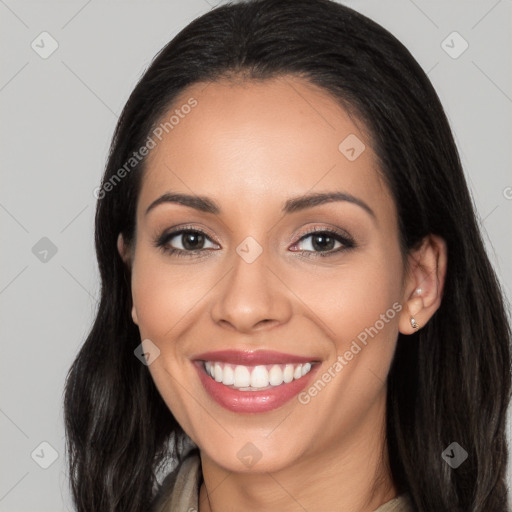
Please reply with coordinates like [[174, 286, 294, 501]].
[[151, 451, 413, 512]]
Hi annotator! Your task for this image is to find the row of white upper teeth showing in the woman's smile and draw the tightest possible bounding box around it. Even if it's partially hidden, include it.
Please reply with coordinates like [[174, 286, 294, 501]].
[[204, 361, 312, 391]]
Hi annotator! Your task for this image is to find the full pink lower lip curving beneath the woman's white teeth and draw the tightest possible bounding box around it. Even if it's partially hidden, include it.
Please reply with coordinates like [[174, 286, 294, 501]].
[[194, 361, 320, 412]]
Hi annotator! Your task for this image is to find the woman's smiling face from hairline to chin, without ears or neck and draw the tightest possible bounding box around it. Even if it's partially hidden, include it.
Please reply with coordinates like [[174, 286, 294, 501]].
[[122, 77, 410, 472]]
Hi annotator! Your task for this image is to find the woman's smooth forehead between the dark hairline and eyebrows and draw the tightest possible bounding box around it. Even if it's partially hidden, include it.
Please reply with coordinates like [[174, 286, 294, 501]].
[[135, 77, 393, 222]]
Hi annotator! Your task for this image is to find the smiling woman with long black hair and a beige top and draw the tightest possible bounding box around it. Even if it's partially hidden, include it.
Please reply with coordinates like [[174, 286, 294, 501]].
[[65, 0, 510, 512]]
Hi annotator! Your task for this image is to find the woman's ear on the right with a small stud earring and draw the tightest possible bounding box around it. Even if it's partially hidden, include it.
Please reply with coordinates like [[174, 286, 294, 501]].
[[398, 235, 448, 334]]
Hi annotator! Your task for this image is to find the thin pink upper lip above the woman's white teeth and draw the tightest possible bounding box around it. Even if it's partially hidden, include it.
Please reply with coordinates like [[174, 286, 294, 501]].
[[192, 350, 318, 366]]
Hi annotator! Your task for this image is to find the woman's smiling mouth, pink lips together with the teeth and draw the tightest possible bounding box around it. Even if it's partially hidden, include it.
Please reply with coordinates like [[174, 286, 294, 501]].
[[193, 351, 319, 413]]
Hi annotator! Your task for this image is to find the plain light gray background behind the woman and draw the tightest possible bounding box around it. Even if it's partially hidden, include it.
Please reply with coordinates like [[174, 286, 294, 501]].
[[0, 0, 512, 512]]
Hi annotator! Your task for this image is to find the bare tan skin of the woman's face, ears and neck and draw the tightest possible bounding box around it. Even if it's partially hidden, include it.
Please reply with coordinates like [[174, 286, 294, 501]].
[[118, 77, 446, 512]]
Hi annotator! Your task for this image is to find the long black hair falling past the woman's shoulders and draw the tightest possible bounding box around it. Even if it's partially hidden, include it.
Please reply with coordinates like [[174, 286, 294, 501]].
[[64, 0, 511, 512]]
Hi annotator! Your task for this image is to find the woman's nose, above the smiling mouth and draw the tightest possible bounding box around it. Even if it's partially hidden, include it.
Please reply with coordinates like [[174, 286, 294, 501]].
[[211, 242, 292, 333]]
